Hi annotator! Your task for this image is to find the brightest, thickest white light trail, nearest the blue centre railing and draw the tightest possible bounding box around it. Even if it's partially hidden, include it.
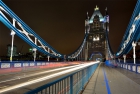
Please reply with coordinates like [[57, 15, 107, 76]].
[[0, 62, 99, 93]]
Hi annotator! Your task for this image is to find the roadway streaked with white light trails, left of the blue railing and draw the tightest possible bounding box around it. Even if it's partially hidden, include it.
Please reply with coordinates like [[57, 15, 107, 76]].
[[0, 64, 81, 94]]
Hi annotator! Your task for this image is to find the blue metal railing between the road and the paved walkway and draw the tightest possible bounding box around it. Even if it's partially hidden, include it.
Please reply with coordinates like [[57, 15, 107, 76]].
[[25, 63, 99, 94]]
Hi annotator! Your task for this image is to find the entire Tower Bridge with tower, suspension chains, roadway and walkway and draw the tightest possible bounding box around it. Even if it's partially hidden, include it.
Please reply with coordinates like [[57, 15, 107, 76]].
[[0, 0, 140, 94]]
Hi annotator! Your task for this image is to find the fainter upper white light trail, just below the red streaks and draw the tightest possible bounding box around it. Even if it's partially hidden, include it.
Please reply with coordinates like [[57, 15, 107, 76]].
[[0, 64, 83, 83]]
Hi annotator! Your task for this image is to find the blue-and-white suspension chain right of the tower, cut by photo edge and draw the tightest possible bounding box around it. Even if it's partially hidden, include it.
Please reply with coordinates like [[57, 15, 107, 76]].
[[116, 0, 140, 57]]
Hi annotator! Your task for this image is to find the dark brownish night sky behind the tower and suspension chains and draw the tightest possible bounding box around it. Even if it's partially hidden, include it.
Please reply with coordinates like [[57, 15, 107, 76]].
[[0, 0, 137, 55]]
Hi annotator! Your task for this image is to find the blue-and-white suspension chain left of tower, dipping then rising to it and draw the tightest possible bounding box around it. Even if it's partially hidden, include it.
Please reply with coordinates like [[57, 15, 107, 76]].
[[0, 0, 88, 59]]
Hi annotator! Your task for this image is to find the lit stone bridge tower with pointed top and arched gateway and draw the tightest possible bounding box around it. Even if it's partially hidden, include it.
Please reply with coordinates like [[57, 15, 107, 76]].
[[85, 6, 109, 60]]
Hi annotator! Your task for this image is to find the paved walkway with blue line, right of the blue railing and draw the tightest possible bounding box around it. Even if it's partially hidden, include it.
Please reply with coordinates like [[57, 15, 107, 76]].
[[82, 65, 140, 94]]
